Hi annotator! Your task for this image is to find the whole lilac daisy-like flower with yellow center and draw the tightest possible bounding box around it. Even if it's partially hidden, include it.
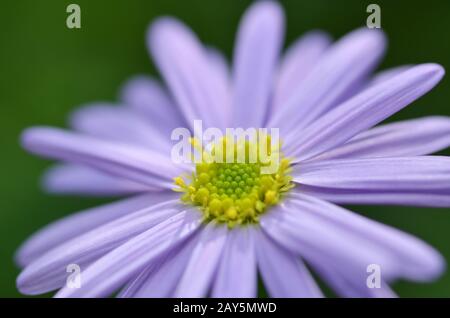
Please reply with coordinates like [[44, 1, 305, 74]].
[[16, 1, 450, 297]]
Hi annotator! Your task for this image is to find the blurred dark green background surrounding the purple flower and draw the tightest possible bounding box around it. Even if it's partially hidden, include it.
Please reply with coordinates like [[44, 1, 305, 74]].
[[0, 0, 450, 297]]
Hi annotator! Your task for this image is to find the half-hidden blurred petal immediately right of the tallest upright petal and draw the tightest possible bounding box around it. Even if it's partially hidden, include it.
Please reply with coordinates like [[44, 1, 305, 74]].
[[273, 31, 331, 111]]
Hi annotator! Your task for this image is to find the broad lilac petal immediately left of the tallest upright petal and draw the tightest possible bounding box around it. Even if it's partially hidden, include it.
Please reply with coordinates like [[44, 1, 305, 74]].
[[148, 18, 230, 128]]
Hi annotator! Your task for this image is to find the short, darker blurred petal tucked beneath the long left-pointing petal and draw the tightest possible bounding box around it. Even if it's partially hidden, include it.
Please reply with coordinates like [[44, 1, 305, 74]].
[[43, 164, 151, 196]]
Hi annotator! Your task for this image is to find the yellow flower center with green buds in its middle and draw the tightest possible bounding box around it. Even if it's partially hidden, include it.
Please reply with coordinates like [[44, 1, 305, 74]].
[[174, 136, 293, 227]]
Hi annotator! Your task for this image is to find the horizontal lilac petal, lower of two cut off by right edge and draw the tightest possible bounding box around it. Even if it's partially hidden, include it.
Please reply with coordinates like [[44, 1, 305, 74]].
[[293, 156, 450, 207]]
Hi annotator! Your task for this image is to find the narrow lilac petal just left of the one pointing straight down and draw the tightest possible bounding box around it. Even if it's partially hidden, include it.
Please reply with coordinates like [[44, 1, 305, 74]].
[[174, 223, 228, 298]]
